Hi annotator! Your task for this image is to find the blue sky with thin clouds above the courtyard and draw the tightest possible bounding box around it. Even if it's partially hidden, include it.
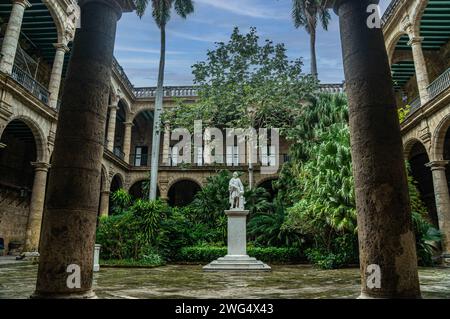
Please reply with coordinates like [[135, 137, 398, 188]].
[[115, 0, 390, 87]]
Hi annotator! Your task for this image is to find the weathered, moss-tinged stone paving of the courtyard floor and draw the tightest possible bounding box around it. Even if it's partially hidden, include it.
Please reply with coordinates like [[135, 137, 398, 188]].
[[0, 264, 450, 299]]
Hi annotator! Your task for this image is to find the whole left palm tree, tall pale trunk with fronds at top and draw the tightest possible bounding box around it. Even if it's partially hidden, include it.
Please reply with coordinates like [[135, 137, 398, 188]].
[[134, 0, 194, 200]]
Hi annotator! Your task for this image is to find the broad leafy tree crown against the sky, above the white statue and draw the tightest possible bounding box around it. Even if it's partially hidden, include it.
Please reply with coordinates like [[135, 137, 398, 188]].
[[165, 28, 317, 130]]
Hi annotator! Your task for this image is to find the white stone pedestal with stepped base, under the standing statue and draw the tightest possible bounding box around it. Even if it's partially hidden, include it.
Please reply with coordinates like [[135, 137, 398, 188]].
[[203, 210, 271, 271]]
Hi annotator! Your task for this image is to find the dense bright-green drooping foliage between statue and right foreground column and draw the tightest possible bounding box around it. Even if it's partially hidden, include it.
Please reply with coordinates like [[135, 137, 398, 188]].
[[289, 123, 356, 242]]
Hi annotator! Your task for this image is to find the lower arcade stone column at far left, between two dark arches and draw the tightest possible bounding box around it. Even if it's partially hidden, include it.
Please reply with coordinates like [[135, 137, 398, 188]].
[[24, 163, 50, 252]]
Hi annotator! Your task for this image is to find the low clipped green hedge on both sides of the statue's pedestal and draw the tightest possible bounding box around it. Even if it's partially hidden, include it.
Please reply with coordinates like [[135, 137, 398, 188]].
[[177, 246, 305, 264]]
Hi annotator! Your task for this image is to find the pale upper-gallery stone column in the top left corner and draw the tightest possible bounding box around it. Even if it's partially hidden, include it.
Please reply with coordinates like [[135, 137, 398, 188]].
[[0, 0, 31, 74]]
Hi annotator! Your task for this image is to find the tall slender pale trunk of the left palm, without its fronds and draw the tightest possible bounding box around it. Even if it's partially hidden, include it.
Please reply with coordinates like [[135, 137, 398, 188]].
[[149, 25, 166, 200]]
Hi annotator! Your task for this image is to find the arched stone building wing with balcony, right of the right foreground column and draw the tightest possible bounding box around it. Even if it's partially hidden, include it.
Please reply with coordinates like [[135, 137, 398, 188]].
[[383, 0, 450, 253]]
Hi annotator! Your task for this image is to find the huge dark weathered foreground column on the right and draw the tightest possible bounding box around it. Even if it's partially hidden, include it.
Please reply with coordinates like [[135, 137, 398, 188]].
[[335, 0, 420, 298]]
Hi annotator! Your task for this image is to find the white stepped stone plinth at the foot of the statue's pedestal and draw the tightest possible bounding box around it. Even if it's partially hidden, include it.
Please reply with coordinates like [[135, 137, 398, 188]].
[[203, 255, 272, 272]]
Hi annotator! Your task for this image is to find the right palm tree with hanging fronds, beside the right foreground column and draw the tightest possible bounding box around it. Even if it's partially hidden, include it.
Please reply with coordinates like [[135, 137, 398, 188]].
[[292, 0, 331, 79]]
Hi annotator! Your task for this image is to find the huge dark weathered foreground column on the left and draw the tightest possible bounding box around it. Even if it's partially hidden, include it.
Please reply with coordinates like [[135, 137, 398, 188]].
[[34, 0, 124, 298]]
